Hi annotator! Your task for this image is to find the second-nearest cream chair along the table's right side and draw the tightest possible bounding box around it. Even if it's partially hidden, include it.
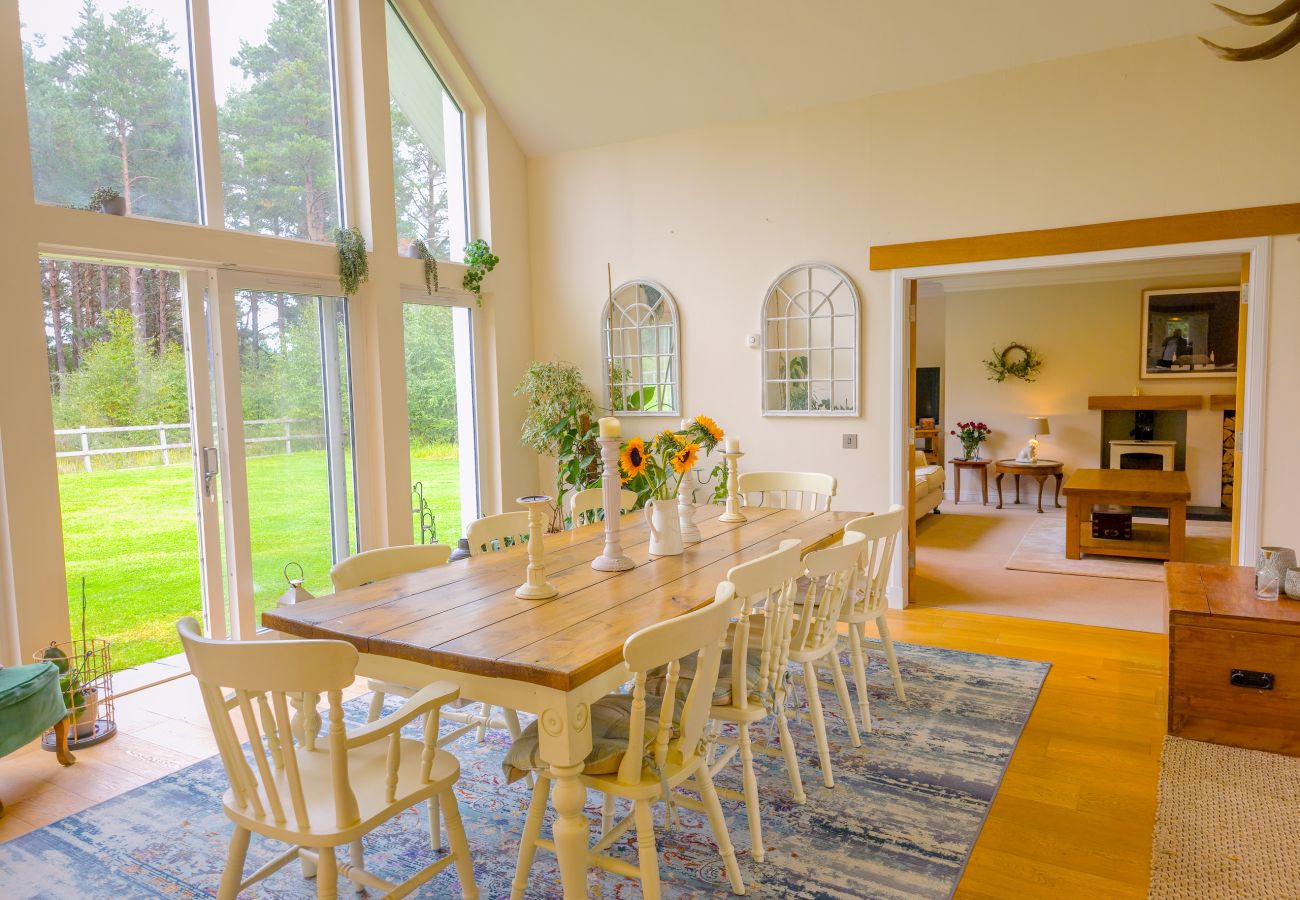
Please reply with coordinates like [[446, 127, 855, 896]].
[[709, 538, 807, 862]]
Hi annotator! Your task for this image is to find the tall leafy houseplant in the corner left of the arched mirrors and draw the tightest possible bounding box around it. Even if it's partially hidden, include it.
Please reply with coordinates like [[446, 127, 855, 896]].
[[515, 362, 601, 531]]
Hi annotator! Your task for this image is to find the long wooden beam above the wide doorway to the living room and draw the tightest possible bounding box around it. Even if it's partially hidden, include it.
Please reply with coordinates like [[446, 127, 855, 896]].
[[870, 203, 1300, 271]]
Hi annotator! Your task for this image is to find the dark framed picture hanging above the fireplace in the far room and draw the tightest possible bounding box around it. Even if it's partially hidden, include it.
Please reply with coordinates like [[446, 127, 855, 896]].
[[1139, 285, 1242, 378]]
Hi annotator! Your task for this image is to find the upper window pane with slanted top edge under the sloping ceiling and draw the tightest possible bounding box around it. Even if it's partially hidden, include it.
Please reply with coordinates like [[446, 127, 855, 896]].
[[387, 5, 467, 260]]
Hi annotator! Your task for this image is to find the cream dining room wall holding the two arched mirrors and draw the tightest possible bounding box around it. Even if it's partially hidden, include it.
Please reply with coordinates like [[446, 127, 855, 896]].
[[529, 29, 1300, 540]]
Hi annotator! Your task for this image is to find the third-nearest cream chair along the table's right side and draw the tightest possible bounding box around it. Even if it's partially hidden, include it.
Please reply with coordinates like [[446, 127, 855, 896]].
[[790, 531, 866, 787]]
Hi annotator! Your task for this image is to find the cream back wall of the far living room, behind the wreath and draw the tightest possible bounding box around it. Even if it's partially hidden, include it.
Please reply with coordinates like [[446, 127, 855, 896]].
[[941, 272, 1239, 506]]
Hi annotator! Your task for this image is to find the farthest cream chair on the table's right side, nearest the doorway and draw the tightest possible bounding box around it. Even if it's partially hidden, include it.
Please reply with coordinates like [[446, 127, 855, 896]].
[[840, 503, 907, 731]]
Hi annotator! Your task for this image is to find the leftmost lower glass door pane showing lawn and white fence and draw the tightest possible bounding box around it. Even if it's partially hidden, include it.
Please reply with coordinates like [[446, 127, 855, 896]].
[[40, 259, 203, 668]]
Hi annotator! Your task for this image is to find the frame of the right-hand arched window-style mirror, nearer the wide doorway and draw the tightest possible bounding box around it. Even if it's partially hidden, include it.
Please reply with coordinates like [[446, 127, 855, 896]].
[[759, 261, 862, 416]]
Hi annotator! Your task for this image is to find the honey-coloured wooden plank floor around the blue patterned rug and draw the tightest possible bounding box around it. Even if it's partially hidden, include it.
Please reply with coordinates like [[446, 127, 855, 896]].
[[0, 607, 1166, 900]]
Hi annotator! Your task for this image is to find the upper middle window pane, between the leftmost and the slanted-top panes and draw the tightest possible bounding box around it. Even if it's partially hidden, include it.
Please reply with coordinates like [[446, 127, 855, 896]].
[[211, 0, 339, 241]]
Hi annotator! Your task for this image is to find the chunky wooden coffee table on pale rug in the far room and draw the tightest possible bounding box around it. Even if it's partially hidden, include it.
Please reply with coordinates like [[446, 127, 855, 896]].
[[1062, 468, 1192, 562]]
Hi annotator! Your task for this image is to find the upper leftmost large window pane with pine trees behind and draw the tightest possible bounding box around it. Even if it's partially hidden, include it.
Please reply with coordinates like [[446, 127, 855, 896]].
[[18, 0, 199, 222]]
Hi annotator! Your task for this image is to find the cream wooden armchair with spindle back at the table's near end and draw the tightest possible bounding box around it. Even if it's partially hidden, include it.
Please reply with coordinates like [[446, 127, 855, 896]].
[[177, 616, 478, 900]]
